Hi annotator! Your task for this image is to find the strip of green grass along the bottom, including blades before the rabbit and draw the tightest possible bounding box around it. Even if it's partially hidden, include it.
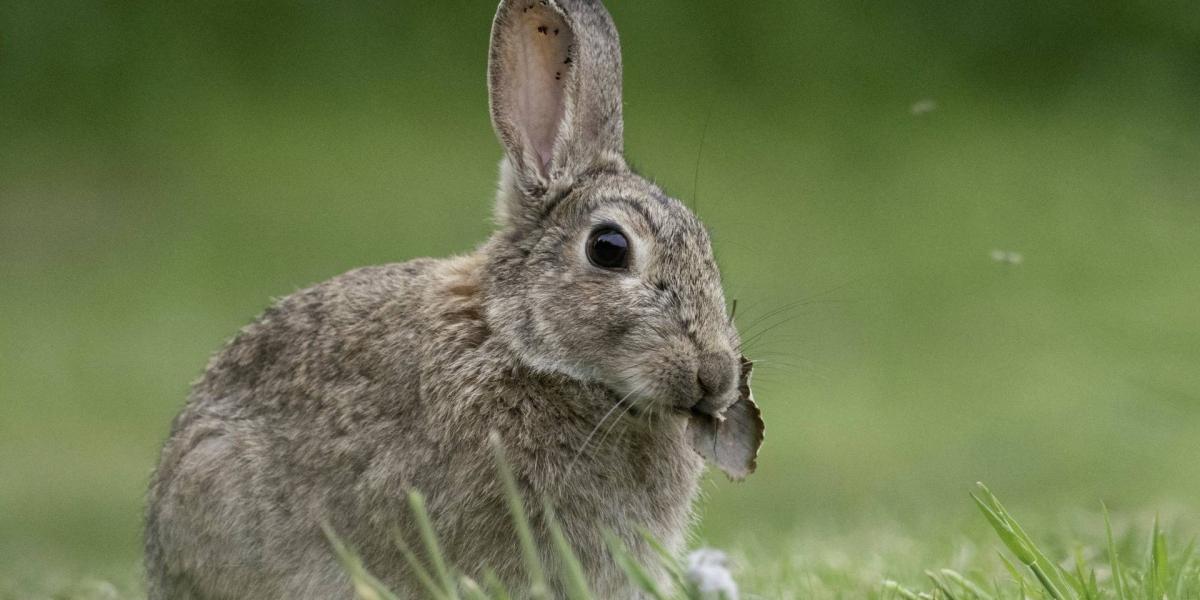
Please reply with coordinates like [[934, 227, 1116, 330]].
[[0, 482, 1200, 600]]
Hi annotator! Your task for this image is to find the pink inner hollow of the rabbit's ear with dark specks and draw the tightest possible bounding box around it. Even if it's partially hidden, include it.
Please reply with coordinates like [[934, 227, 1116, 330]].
[[509, 1, 572, 173]]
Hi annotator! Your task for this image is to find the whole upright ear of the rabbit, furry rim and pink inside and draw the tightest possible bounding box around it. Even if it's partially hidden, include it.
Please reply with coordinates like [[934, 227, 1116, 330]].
[[488, 0, 624, 197]]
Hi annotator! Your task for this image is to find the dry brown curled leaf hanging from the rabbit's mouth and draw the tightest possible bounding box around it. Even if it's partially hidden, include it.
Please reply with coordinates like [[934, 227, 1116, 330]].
[[688, 356, 766, 481]]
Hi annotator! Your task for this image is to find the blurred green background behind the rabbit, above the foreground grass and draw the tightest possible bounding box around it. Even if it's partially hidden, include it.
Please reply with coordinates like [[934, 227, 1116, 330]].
[[0, 0, 1200, 590]]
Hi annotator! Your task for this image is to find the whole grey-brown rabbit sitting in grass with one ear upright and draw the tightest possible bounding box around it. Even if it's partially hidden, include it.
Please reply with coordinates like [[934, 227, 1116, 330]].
[[145, 0, 761, 600]]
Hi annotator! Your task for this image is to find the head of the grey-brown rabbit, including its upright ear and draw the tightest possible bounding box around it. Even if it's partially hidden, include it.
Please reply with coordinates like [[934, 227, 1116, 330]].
[[486, 0, 740, 414]]
